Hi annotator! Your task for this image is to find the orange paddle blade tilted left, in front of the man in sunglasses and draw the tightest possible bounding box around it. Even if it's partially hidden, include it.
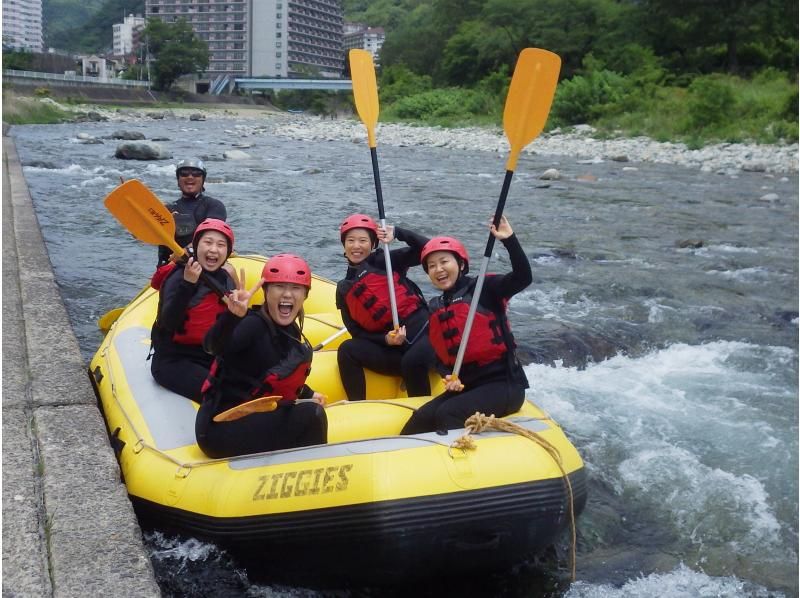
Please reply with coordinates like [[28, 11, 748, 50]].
[[103, 179, 183, 256]]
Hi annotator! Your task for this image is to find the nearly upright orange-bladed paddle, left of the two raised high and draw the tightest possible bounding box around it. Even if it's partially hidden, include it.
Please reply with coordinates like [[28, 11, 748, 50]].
[[349, 50, 400, 330]]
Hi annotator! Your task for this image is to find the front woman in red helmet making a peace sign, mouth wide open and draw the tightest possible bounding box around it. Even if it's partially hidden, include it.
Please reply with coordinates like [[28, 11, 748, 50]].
[[195, 254, 328, 459]]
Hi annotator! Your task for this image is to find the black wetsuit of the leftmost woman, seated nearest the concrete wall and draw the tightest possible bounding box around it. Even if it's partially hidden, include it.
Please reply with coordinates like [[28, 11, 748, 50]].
[[150, 265, 233, 402]]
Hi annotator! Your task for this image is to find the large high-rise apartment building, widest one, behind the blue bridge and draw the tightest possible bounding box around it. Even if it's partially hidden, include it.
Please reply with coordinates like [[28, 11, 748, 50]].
[[145, 0, 344, 81]]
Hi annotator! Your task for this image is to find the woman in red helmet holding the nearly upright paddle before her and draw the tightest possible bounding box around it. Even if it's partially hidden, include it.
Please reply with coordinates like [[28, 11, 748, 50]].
[[336, 214, 435, 401]]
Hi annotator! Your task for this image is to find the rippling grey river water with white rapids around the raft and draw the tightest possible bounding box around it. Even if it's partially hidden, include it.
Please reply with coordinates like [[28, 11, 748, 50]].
[[11, 119, 798, 598]]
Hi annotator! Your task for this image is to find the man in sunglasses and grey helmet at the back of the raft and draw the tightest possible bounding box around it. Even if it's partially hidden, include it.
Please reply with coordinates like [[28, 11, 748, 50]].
[[157, 159, 228, 268]]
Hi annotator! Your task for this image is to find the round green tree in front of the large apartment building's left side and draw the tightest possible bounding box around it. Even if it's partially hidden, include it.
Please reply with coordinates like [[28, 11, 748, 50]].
[[144, 19, 209, 91]]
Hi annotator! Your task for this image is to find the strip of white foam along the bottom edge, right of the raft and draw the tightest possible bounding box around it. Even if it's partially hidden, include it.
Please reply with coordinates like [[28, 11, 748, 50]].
[[564, 564, 784, 598]]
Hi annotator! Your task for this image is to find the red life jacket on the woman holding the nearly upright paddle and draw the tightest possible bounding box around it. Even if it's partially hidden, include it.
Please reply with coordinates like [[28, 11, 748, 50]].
[[344, 263, 424, 332]]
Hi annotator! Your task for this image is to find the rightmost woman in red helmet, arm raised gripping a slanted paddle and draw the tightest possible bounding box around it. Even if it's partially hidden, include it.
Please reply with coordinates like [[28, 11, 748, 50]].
[[401, 216, 533, 434]]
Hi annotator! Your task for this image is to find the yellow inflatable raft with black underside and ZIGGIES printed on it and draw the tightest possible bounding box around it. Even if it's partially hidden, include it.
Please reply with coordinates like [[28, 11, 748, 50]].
[[90, 256, 586, 583]]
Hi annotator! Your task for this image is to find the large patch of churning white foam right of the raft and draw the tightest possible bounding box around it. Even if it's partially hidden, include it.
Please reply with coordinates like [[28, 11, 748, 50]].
[[525, 341, 797, 596]]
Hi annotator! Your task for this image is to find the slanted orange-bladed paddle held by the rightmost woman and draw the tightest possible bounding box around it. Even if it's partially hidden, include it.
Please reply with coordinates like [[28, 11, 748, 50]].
[[452, 48, 561, 380]]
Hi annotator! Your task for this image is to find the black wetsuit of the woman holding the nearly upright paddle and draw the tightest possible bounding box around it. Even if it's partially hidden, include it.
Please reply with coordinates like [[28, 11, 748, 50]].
[[336, 227, 436, 401]]
